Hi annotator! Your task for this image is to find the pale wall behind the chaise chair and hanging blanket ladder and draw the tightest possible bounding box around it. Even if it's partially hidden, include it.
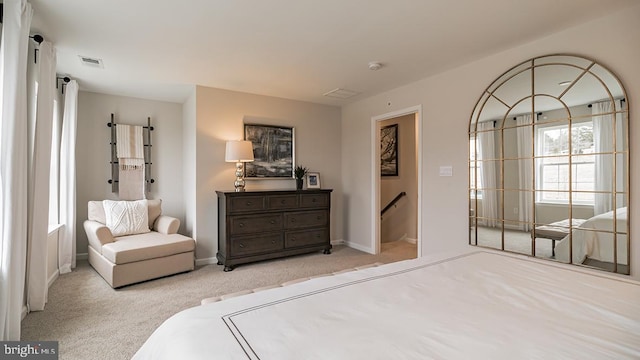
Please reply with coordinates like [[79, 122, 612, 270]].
[[76, 91, 185, 254]]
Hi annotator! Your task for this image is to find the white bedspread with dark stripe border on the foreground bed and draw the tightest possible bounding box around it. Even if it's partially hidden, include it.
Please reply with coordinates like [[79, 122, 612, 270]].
[[134, 251, 640, 360]]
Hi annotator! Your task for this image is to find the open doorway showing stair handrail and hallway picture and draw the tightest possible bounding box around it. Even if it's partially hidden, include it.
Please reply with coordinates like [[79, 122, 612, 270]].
[[371, 106, 422, 257]]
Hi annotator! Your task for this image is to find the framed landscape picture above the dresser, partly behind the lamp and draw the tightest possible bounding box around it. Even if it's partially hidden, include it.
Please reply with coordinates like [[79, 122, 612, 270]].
[[244, 124, 295, 179]]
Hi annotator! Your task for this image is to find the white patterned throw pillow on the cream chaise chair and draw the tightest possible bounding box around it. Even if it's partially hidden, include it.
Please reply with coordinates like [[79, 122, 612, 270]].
[[102, 200, 150, 236]]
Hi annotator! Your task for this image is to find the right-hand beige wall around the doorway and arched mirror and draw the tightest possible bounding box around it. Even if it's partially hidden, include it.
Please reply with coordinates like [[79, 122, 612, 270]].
[[342, 5, 640, 278]]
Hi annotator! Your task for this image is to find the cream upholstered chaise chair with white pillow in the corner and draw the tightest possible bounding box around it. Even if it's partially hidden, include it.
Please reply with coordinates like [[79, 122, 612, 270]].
[[84, 200, 195, 288]]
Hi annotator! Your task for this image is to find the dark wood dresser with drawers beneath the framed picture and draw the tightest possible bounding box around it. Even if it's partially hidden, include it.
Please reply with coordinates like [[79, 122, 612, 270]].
[[216, 189, 332, 271]]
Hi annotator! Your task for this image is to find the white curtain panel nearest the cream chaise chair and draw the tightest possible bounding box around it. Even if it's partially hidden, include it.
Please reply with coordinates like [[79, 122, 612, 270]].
[[58, 80, 78, 274]]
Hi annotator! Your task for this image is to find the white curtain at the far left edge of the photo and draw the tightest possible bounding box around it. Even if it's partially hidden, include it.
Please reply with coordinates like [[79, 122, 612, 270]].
[[0, 0, 33, 341]]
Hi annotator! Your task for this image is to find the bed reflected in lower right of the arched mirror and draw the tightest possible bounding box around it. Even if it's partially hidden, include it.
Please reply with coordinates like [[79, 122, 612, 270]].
[[555, 207, 628, 265]]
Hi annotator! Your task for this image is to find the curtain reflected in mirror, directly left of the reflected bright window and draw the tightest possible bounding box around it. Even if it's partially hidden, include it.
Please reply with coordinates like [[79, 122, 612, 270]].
[[516, 114, 533, 231]]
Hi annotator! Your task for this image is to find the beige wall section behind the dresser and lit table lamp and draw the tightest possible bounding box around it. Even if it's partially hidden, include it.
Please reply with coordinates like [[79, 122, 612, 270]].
[[188, 86, 343, 264]]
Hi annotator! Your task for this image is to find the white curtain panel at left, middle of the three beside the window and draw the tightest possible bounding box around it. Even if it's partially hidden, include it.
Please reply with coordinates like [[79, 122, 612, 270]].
[[27, 41, 56, 311]]
